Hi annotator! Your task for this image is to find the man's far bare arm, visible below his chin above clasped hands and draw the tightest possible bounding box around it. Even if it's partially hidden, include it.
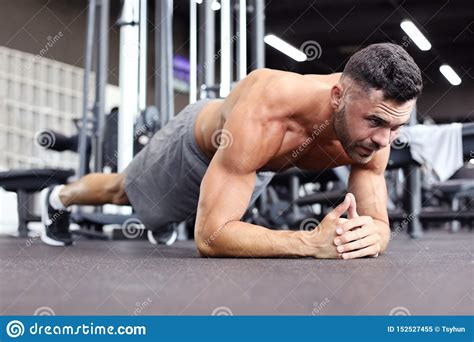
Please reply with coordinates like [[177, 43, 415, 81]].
[[349, 147, 390, 224]]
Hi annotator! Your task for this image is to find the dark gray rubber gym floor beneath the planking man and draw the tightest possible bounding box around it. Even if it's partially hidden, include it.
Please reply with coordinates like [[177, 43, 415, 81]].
[[0, 230, 474, 315]]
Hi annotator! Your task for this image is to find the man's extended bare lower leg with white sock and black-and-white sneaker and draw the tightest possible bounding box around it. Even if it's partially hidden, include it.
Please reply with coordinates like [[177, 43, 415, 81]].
[[41, 173, 130, 246]]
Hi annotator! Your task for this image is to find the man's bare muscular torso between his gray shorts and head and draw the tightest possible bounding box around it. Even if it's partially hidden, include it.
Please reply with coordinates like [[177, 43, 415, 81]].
[[191, 69, 350, 172]]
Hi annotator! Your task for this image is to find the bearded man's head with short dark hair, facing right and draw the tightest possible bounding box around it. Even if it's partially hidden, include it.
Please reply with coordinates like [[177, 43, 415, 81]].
[[331, 43, 422, 163]]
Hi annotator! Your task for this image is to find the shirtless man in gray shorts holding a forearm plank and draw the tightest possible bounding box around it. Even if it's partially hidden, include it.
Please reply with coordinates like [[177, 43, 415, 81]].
[[43, 43, 422, 259]]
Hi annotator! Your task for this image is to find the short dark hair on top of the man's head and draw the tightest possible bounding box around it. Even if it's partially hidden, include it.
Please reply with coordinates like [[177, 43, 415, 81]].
[[342, 43, 423, 103]]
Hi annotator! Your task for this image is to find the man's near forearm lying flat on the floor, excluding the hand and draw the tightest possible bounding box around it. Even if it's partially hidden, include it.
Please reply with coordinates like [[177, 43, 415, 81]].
[[196, 221, 314, 257]]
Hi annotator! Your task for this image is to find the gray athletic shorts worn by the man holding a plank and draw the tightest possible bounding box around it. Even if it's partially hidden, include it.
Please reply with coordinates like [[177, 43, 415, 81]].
[[124, 100, 274, 230]]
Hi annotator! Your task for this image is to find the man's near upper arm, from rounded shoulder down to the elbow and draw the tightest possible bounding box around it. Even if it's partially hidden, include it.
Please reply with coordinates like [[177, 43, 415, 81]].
[[195, 87, 285, 243]]
